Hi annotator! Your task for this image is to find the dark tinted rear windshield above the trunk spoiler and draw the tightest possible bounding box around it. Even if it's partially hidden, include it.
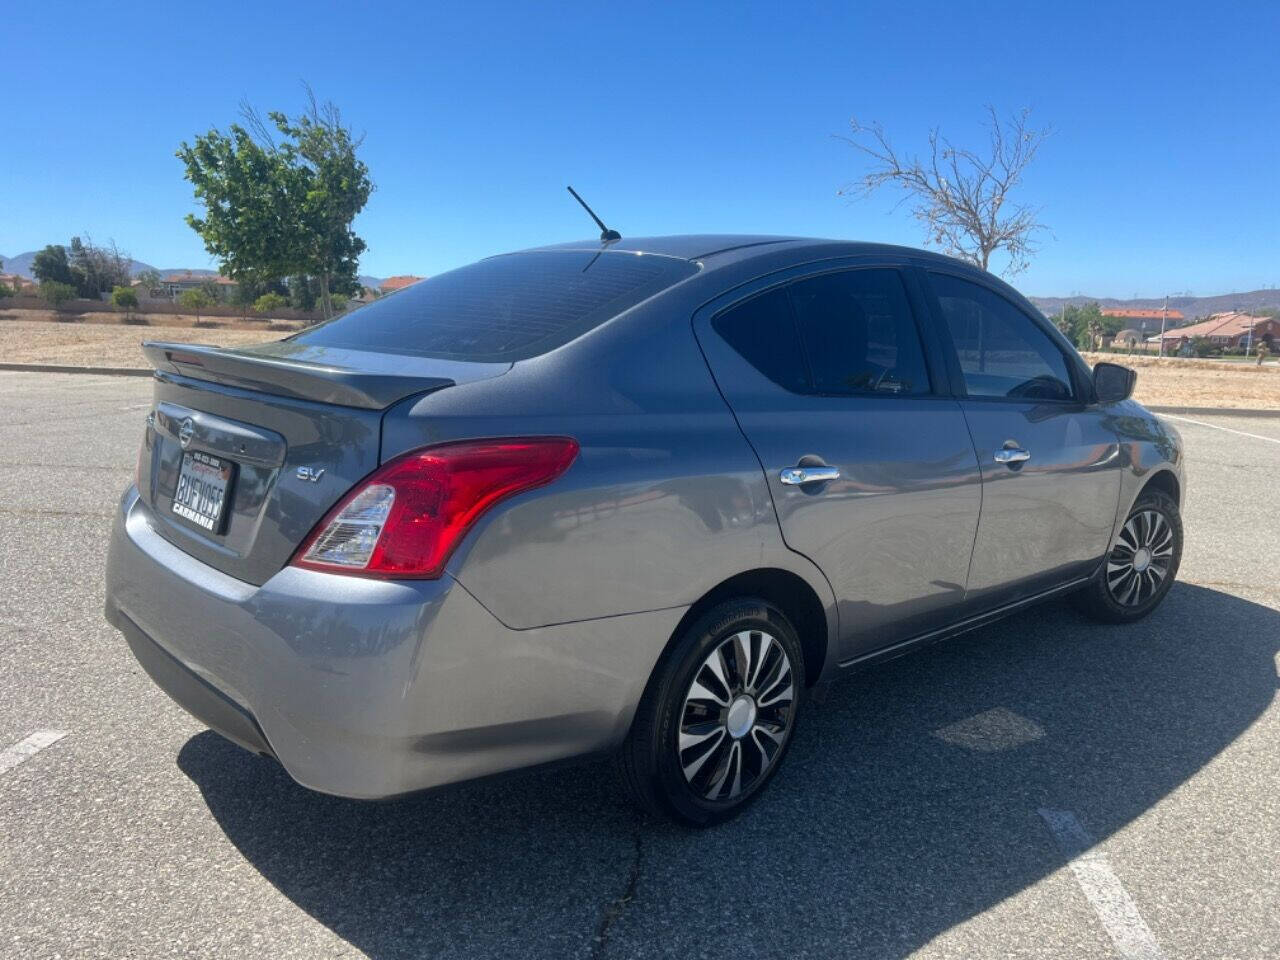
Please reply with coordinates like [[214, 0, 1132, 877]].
[[291, 251, 698, 362]]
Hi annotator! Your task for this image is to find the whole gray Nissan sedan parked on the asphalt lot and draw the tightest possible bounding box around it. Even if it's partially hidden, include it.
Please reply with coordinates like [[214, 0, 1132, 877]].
[[106, 234, 1183, 824]]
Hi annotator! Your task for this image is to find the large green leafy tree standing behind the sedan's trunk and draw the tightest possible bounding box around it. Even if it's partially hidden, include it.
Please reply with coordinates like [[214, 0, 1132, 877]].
[[178, 88, 374, 316]]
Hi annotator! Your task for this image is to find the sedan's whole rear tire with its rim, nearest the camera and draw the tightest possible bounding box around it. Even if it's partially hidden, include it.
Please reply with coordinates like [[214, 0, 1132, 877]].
[[617, 598, 805, 827]]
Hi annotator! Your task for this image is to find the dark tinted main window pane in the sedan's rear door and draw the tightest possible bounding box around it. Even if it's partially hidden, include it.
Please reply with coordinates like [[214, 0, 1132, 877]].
[[791, 270, 929, 394]]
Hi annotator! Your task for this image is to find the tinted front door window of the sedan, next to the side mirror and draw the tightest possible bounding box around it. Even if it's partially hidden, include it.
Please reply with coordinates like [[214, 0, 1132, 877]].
[[931, 274, 1074, 401]]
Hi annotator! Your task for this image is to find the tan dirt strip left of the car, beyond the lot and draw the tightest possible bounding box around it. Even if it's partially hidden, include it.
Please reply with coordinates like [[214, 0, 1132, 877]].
[[0, 323, 289, 369]]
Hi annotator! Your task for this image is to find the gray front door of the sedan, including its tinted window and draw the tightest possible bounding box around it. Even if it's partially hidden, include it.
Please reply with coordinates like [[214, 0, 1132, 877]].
[[928, 273, 1120, 609]]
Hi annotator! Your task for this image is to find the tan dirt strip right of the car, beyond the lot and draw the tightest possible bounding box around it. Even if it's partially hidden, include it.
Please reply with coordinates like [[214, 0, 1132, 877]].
[[1084, 353, 1280, 410]]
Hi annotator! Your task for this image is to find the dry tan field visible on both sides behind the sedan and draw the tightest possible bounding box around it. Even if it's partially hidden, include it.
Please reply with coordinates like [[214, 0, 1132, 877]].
[[0, 316, 1280, 411]]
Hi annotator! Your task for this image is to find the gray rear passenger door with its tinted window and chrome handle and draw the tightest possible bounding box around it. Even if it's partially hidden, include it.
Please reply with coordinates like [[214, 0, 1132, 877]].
[[695, 265, 980, 659]]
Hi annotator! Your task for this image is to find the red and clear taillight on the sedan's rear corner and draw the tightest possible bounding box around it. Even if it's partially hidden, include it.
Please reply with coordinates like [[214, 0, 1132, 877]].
[[293, 436, 577, 579]]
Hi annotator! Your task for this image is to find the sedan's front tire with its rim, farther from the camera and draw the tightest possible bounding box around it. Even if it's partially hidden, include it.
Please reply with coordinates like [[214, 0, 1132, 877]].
[[1075, 490, 1183, 623]]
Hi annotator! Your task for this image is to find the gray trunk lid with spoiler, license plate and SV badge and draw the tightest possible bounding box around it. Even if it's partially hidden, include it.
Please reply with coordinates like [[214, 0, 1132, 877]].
[[138, 342, 511, 584]]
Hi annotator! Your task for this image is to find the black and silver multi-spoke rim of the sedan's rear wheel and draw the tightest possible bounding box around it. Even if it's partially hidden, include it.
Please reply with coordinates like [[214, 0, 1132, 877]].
[[677, 630, 796, 801]]
